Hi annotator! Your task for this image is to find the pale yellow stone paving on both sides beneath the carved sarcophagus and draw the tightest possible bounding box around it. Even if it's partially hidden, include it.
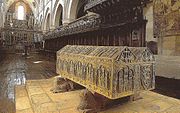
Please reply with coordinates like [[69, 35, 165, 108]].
[[16, 79, 180, 113]]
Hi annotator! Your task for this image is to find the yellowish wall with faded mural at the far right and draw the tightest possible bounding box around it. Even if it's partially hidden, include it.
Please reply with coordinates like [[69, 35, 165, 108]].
[[153, 0, 180, 56]]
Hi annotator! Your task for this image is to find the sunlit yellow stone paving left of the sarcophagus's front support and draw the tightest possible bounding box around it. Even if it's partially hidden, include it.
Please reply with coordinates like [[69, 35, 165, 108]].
[[16, 79, 80, 113]]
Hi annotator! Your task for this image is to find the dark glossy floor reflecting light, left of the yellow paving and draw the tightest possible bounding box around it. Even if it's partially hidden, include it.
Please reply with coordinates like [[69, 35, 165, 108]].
[[0, 53, 55, 113]]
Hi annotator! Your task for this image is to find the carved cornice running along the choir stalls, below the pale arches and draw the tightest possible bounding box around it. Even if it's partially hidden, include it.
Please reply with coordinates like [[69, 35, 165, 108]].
[[44, 14, 101, 39]]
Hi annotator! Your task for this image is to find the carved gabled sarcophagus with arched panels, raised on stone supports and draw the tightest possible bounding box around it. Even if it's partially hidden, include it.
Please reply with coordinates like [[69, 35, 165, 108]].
[[56, 45, 155, 99]]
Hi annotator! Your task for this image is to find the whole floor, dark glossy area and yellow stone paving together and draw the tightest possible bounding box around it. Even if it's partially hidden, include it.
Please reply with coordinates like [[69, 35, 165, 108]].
[[0, 54, 180, 113]]
